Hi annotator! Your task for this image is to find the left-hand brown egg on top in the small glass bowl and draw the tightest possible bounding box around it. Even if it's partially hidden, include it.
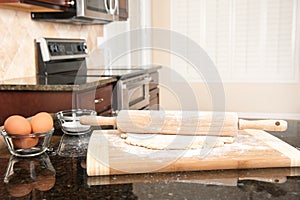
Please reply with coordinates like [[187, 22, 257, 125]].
[[4, 115, 31, 134]]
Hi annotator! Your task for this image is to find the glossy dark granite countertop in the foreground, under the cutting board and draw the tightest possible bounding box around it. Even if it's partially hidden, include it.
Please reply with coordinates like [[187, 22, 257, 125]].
[[0, 121, 300, 200]]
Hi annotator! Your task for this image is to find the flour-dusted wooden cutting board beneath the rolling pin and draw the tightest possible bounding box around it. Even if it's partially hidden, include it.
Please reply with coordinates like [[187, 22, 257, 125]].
[[86, 129, 300, 176]]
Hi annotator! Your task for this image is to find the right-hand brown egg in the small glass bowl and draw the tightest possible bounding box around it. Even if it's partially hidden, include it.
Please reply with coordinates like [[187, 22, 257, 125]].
[[30, 112, 53, 133]]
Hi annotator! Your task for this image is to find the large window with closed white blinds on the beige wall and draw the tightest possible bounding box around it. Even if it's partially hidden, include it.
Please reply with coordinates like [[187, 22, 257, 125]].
[[171, 0, 299, 82]]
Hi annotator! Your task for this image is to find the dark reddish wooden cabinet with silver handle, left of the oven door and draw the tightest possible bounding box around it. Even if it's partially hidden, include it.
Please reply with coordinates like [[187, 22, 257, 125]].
[[76, 84, 113, 115]]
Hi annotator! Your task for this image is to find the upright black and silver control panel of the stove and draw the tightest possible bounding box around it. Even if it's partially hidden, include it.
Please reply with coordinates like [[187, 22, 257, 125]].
[[35, 38, 88, 85]]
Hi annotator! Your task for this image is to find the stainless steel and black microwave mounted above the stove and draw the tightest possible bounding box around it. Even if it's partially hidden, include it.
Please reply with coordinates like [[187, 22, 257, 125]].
[[31, 0, 128, 24]]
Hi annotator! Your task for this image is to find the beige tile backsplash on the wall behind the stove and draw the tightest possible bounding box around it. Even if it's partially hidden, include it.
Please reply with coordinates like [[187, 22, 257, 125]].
[[0, 9, 103, 80]]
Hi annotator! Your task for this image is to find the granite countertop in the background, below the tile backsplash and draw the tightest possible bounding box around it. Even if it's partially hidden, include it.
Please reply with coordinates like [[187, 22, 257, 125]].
[[0, 77, 117, 91]]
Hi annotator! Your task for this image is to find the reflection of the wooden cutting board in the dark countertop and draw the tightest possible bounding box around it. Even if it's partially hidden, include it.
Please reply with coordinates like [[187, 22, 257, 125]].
[[87, 167, 300, 186]]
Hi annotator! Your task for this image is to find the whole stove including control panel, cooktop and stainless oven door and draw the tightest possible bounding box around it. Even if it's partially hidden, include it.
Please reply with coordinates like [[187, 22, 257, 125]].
[[36, 38, 152, 111]]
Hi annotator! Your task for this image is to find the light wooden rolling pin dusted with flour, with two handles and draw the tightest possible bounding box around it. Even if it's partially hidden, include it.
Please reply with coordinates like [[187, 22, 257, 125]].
[[80, 110, 287, 136]]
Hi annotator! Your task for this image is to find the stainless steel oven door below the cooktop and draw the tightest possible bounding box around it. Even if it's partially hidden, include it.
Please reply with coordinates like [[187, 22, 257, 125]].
[[114, 74, 151, 110]]
